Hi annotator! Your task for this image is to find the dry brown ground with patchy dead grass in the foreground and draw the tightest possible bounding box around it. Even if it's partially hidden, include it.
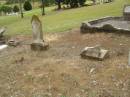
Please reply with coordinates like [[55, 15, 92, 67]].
[[0, 29, 130, 97]]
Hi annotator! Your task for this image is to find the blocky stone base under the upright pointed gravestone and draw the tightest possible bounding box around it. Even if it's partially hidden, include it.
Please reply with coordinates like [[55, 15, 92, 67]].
[[31, 42, 49, 51]]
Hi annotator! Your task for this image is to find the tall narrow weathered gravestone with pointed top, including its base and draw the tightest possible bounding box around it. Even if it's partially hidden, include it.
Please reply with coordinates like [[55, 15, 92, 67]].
[[31, 15, 49, 51]]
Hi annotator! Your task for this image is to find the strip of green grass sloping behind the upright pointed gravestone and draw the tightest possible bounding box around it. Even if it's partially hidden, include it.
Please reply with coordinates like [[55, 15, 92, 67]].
[[0, 0, 130, 35]]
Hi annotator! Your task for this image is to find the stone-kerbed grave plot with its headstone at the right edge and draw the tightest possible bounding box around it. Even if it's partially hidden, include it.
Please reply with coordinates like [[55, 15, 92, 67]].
[[80, 5, 130, 33]]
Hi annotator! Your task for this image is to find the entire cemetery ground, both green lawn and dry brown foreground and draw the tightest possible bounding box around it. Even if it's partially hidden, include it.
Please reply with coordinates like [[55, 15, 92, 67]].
[[0, 0, 130, 97]]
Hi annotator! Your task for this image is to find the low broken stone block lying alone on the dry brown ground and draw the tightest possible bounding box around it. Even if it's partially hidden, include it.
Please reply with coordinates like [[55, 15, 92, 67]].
[[80, 46, 108, 60]]
